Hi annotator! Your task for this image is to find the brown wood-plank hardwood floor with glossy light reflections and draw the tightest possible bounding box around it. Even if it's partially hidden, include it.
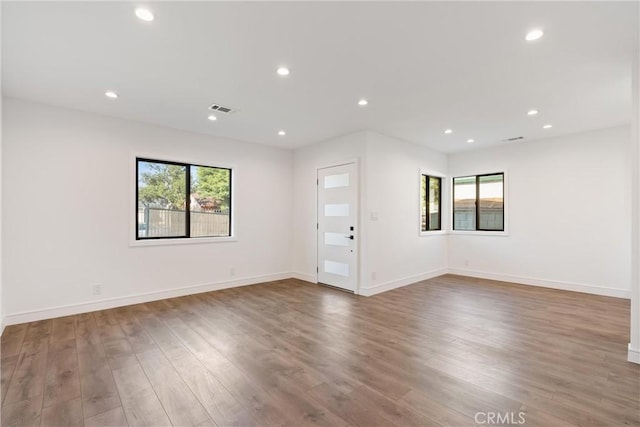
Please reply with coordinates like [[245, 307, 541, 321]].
[[1, 275, 640, 427]]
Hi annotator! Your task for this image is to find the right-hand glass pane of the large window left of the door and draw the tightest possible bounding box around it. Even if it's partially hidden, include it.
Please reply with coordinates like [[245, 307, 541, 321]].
[[190, 166, 231, 237]]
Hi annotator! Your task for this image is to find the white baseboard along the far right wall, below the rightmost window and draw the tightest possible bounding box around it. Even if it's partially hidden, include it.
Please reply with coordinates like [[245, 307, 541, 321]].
[[449, 268, 631, 299]]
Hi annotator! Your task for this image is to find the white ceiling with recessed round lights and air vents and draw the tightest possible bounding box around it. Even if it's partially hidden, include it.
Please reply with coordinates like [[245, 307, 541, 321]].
[[2, 1, 639, 152]]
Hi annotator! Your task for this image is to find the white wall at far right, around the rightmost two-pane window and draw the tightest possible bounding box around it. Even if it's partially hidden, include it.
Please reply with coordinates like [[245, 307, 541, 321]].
[[449, 127, 631, 298]]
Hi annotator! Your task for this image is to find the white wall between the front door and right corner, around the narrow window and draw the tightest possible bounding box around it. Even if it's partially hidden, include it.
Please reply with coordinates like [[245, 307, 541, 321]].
[[361, 132, 449, 295]]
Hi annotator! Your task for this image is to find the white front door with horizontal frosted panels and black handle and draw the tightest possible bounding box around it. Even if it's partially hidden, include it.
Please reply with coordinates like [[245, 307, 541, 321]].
[[318, 163, 359, 292]]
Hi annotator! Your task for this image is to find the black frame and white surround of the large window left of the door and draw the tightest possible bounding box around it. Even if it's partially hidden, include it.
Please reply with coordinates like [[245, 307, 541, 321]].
[[129, 153, 238, 247]]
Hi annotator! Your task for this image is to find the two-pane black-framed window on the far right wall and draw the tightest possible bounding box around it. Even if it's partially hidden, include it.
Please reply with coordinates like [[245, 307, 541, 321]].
[[453, 173, 504, 231]]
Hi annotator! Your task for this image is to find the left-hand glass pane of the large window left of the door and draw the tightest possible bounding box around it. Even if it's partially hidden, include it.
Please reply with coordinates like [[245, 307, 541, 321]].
[[137, 160, 187, 239]]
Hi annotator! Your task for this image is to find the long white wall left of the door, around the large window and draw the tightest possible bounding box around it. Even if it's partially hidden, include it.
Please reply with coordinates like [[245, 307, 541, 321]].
[[2, 99, 292, 323]]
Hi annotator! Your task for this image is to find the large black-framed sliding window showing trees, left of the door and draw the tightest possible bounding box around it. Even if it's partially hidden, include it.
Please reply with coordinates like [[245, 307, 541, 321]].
[[136, 158, 231, 240]]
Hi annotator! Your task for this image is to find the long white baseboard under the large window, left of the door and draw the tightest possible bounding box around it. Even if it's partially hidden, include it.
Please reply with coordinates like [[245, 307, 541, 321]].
[[2, 272, 292, 330]]
